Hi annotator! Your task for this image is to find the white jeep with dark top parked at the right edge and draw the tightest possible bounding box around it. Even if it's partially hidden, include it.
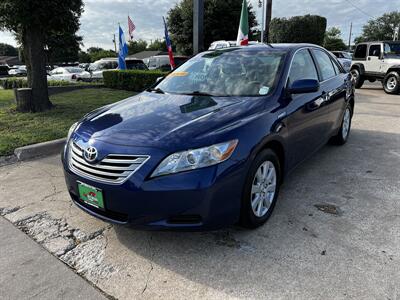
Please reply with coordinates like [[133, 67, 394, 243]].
[[350, 41, 400, 94]]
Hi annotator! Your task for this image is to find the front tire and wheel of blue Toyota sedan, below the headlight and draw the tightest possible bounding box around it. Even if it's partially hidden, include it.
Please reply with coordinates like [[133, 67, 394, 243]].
[[240, 149, 282, 228]]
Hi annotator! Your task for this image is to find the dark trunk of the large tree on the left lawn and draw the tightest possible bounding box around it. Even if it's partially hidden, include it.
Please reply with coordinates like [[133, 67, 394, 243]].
[[17, 28, 52, 112]]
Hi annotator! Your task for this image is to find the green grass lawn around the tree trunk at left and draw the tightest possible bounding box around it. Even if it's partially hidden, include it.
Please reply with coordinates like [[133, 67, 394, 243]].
[[0, 89, 134, 156]]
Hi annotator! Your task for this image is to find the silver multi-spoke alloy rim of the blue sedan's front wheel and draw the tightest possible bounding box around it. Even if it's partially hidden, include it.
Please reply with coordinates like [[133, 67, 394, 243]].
[[250, 161, 277, 218]]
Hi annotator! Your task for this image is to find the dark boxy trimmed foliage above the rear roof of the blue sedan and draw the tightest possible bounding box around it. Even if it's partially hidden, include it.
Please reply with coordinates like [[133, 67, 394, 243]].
[[270, 15, 327, 46]]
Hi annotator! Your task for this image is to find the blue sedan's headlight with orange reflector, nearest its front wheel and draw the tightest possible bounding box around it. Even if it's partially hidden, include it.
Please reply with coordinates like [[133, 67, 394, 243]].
[[151, 140, 239, 177]]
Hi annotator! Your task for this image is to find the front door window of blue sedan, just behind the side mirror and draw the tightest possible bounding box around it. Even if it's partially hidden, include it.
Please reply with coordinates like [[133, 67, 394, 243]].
[[289, 49, 318, 82]]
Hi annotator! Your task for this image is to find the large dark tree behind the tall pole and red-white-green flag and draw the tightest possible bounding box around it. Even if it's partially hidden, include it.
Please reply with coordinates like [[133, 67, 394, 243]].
[[167, 0, 257, 55]]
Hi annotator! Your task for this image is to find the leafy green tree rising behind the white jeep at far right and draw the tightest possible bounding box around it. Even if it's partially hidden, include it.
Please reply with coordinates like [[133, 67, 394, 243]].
[[355, 11, 400, 43]]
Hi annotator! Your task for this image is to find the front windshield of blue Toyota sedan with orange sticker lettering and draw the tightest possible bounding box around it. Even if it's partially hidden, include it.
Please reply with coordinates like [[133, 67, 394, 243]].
[[154, 49, 286, 96]]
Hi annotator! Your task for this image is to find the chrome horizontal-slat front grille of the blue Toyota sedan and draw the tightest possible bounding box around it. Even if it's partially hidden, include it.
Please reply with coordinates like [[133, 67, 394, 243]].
[[68, 142, 150, 184]]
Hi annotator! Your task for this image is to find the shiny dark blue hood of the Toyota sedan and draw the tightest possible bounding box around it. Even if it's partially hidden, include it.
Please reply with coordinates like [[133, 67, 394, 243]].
[[76, 92, 266, 149]]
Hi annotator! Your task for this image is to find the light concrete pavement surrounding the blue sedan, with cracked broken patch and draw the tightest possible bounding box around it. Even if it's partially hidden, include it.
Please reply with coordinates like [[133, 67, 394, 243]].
[[0, 85, 400, 299]]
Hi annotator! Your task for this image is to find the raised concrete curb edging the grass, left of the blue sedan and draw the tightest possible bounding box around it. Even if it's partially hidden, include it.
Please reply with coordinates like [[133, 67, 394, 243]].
[[14, 138, 66, 161]]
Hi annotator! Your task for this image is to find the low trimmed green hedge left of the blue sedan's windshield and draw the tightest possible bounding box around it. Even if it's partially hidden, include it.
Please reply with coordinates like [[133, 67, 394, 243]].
[[103, 70, 168, 92]]
